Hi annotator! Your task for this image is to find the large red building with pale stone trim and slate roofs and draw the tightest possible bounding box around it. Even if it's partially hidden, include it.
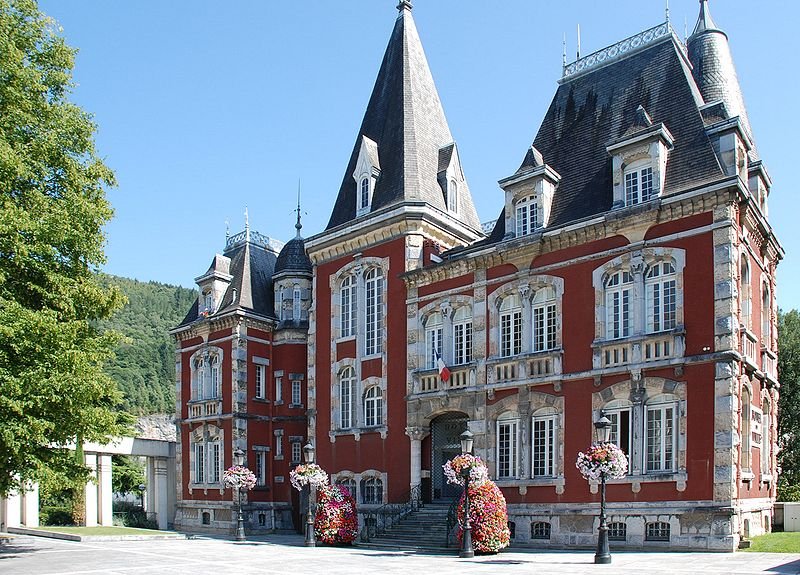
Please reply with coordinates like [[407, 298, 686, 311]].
[[175, 0, 783, 550]]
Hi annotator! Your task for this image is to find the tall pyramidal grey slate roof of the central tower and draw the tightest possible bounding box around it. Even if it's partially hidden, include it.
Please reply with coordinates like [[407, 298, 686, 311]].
[[326, 2, 481, 230]]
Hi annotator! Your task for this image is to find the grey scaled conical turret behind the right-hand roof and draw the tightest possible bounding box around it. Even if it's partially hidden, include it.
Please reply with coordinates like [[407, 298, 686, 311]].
[[687, 0, 755, 154]]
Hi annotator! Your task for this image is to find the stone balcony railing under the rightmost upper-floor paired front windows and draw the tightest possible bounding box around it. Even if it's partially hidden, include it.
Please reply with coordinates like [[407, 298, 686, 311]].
[[592, 332, 684, 369]]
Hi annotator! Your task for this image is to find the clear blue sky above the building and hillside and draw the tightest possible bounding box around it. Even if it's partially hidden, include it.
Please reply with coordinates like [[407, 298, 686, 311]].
[[40, 0, 800, 309]]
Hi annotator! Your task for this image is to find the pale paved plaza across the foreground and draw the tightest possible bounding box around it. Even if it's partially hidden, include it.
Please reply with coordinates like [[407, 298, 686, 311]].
[[0, 535, 800, 575]]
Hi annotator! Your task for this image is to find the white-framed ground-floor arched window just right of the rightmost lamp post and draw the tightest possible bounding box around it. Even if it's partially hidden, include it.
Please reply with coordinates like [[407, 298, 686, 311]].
[[644, 395, 678, 473]]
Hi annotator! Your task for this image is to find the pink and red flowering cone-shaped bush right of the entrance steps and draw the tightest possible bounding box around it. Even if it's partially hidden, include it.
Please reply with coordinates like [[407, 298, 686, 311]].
[[458, 481, 511, 553]]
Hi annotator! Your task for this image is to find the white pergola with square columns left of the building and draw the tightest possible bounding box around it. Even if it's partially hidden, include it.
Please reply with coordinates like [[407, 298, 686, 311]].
[[0, 437, 176, 531]]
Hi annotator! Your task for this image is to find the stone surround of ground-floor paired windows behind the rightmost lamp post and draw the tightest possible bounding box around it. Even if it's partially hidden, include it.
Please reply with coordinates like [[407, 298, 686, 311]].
[[589, 377, 688, 493]]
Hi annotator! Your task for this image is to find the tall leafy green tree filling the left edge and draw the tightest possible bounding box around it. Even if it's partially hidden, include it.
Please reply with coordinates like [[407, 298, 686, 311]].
[[0, 0, 126, 494]]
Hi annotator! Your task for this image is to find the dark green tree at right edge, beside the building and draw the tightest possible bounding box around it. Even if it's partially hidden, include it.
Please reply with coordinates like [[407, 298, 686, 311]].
[[778, 309, 800, 500]]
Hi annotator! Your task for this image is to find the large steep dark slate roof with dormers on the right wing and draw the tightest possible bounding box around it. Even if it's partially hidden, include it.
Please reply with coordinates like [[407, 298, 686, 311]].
[[480, 31, 723, 243]]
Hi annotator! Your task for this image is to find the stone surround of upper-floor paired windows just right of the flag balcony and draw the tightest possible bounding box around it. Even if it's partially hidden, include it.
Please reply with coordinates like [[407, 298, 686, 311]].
[[487, 275, 564, 361]]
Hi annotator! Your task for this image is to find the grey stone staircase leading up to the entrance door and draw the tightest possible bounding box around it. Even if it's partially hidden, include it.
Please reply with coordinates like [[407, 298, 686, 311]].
[[359, 502, 455, 553]]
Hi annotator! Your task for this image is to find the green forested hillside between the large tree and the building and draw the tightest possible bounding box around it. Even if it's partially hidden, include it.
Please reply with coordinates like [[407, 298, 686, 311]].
[[101, 276, 197, 415]]
